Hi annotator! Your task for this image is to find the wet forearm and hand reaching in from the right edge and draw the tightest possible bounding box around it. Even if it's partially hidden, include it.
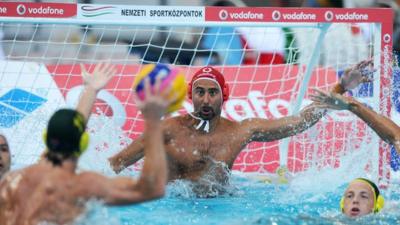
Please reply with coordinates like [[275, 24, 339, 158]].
[[312, 90, 400, 154]]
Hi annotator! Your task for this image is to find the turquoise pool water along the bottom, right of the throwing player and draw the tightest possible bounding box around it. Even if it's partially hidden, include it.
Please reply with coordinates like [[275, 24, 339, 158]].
[[78, 176, 400, 225]]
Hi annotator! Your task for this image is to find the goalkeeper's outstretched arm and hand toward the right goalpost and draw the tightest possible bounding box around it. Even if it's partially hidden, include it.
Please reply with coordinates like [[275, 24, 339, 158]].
[[242, 60, 374, 142]]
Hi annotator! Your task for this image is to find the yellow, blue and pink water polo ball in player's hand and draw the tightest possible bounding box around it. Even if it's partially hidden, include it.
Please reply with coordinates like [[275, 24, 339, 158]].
[[133, 64, 187, 113]]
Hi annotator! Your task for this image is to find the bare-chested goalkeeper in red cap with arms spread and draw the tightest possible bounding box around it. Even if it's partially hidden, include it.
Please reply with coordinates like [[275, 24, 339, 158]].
[[110, 61, 376, 197]]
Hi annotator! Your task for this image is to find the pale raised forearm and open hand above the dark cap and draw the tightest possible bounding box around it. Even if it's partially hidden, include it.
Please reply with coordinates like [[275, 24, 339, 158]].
[[76, 63, 116, 122]]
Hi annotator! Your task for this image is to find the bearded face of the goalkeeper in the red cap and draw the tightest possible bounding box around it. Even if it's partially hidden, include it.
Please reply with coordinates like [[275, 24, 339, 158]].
[[192, 79, 222, 120]]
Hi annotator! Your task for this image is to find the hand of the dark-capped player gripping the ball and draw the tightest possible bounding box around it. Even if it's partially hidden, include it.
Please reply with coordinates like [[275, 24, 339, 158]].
[[136, 76, 178, 120]]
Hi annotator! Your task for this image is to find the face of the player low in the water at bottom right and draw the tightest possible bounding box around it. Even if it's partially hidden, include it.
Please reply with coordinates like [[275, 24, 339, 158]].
[[343, 180, 375, 217]]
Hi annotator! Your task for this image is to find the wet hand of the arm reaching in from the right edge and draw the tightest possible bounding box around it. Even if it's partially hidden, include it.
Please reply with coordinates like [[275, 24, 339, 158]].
[[310, 89, 350, 110]]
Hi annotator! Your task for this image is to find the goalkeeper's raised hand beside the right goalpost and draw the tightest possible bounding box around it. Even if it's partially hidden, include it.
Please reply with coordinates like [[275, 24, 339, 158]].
[[340, 59, 376, 91]]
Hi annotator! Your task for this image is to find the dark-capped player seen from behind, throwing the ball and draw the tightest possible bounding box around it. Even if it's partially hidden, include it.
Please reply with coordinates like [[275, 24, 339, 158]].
[[0, 64, 170, 225]]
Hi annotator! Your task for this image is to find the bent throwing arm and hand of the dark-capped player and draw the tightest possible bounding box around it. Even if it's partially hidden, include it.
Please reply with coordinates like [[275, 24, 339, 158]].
[[90, 76, 173, 205]]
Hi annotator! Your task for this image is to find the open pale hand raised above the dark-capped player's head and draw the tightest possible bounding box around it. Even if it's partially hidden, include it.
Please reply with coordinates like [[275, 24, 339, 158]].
[[81, 62, 117, 91]]
